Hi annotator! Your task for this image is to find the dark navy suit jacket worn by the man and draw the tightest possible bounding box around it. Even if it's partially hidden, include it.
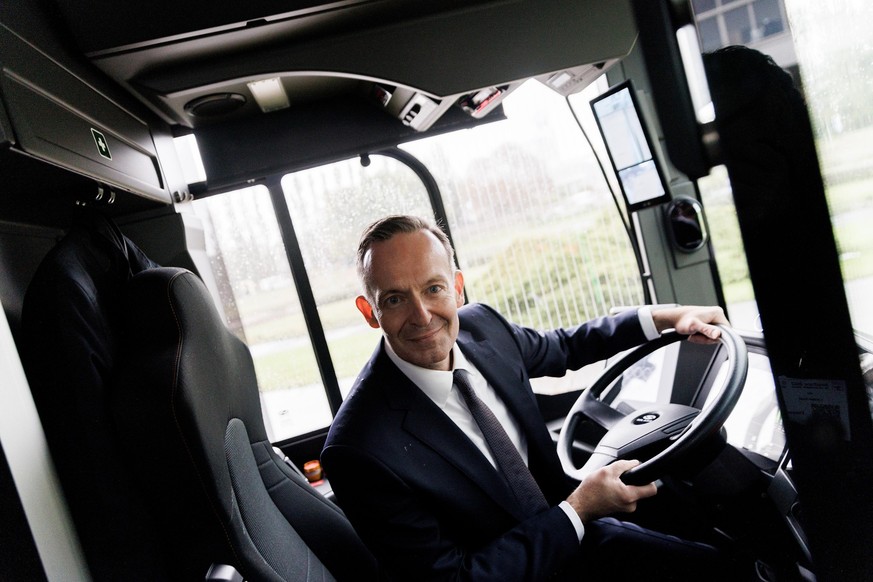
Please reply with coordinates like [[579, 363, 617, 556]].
[[322, 304, 645, 582]]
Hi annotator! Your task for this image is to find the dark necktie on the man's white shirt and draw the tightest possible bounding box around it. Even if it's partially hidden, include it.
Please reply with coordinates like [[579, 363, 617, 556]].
[[453, 370, 549, 515]]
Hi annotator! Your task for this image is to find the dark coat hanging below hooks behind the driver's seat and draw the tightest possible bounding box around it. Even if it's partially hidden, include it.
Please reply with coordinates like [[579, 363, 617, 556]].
[[21, 208, 163, 581]]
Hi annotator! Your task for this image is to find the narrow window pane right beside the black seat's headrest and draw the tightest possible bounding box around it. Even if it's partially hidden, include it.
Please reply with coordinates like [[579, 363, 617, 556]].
[[194, 186, 331, 442]]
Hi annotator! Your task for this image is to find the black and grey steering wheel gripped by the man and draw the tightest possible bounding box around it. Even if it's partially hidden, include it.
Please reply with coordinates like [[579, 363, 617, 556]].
[[558, 325, 749, 485]]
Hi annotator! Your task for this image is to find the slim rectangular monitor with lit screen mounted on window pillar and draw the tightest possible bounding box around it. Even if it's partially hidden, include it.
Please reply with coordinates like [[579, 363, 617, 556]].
[[591, 80, 670, 212]]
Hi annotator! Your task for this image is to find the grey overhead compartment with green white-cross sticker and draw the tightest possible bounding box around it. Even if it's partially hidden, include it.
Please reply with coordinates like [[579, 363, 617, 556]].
[[0, 23, 184, 204]]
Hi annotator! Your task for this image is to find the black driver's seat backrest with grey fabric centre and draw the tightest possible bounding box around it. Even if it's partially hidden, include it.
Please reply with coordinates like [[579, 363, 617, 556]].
[[112, 268, 376, 581]]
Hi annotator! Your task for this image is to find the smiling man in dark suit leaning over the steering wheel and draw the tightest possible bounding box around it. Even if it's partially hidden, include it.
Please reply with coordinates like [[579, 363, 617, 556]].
[[322, 216, 740, 581]]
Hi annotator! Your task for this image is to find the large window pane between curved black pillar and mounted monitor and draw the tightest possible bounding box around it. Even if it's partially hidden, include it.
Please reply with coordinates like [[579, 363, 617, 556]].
[[403, 81, 644, 330]]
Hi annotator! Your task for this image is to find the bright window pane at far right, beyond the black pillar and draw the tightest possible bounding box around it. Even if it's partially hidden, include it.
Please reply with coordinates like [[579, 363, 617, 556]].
[[786, 2, 873, 337]]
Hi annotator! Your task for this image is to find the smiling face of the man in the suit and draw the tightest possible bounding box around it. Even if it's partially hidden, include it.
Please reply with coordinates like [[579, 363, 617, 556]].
[[356, 231, 464, 370]]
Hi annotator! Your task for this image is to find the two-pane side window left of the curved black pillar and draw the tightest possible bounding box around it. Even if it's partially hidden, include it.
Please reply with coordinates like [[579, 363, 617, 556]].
[[194, 156, 432, 442]]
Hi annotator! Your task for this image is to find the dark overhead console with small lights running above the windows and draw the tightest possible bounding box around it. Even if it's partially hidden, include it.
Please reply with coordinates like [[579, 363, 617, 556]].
[[55, 0, 636, 130]]
